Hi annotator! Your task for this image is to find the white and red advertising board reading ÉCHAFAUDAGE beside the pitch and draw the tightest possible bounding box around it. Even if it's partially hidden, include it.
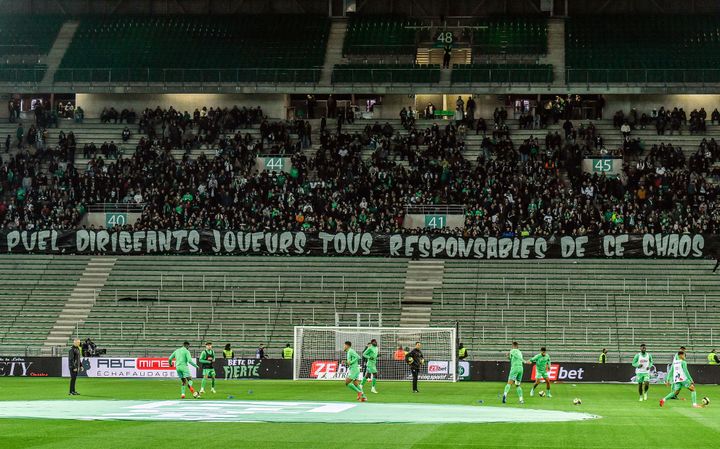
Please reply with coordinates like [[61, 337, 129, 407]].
[[62, 357, 195, 379]]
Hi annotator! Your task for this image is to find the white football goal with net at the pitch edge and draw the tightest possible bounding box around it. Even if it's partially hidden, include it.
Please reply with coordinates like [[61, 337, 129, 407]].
[[293, 326, 457, 382]]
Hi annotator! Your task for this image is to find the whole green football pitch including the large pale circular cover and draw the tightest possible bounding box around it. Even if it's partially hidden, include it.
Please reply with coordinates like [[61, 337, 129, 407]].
[[0, 377, 720, 449]]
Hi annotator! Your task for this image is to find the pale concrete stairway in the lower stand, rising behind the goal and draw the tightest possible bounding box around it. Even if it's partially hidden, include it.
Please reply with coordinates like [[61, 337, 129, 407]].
[[400, 260, 445, 327]]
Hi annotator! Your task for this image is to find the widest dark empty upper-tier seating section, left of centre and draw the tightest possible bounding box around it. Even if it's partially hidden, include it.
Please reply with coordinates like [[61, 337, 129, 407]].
[[55, 15, 330, 83]]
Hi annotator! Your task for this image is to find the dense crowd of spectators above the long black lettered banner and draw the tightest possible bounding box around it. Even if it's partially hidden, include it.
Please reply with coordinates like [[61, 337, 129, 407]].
[[0, 101, 720, 236]]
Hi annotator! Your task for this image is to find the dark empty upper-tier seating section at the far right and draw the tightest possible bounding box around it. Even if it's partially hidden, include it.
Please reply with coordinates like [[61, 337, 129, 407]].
[[565, 15, 720, 83]]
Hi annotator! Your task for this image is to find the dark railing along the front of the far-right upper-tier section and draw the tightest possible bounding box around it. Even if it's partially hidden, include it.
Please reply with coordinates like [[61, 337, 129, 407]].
[[565, 69, 720, 84]]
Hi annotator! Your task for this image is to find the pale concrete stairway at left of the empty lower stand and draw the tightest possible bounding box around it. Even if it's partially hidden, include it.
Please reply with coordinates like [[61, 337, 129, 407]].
[[41, 257, 117, 355]]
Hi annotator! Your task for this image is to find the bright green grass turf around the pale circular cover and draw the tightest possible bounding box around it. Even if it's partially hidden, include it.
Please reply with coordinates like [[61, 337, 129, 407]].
[[0, 377, 720, 449]]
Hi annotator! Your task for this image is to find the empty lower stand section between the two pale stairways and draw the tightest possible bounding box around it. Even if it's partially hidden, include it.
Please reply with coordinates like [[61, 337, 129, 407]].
[[80, 256, 407, 358]]
